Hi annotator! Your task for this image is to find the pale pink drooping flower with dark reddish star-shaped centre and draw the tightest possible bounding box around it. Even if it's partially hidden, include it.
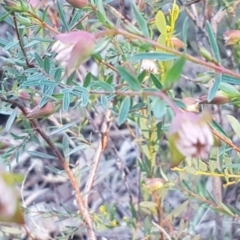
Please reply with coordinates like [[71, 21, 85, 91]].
[[170, 112, 214, 159]]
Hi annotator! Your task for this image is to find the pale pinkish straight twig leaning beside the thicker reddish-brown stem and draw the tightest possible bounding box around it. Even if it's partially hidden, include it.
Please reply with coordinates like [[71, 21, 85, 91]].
[[84, 109, 112, 207]]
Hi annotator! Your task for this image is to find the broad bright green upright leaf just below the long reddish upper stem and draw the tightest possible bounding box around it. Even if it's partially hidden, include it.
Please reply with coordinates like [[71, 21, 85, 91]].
[[163, 56, 185, 89]]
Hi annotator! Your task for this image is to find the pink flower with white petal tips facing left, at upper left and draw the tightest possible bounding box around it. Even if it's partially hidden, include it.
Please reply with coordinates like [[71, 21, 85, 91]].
[[52, 31, 96, 75]]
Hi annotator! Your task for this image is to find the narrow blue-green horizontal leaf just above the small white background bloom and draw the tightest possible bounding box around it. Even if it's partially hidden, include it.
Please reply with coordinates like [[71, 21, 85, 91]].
[[131, 52, 178, 62]]
